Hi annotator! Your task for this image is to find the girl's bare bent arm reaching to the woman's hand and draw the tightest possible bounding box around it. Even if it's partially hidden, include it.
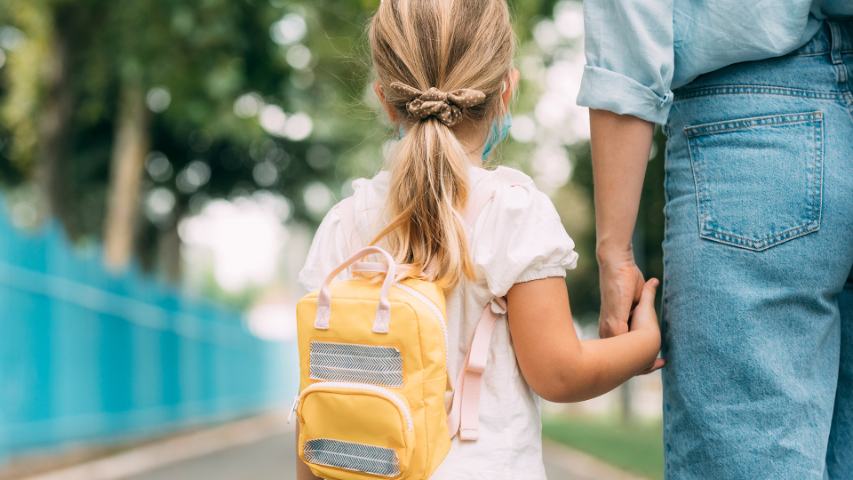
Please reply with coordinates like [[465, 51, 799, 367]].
[[507, 277, 663, 402]]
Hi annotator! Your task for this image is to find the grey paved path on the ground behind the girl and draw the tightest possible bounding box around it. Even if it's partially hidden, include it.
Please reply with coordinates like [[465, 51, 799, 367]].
[[11, 414, 637, 480]]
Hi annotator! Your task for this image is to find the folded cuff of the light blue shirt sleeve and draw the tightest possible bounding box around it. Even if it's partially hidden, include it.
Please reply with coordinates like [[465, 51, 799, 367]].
[[578, 65, 673, 124]]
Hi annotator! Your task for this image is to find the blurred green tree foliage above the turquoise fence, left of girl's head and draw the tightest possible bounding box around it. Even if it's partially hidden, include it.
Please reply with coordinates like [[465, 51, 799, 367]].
[[0, 0, 564, 229]]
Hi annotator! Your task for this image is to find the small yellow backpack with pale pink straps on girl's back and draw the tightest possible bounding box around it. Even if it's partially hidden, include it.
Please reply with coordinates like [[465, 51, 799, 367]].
[[293, 182, 497, 480]]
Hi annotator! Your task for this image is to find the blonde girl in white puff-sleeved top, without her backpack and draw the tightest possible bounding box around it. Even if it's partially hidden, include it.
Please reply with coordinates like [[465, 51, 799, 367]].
[[299, 0, 660, 480]]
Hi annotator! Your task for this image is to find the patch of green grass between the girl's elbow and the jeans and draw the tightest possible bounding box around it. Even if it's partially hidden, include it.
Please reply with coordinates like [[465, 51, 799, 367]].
[[542, 416, 664, 479]]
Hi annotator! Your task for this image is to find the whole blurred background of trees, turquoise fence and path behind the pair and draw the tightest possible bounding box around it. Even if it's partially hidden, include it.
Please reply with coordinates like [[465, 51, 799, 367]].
[[0, 0, 663, 479]]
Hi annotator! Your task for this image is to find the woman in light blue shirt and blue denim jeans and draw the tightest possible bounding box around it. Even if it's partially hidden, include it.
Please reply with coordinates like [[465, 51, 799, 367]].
[[578, 0, 853, 479]]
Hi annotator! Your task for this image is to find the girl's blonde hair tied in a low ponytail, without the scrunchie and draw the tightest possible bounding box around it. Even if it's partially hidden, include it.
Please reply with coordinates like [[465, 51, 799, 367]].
[[368, 0, 514, 288]]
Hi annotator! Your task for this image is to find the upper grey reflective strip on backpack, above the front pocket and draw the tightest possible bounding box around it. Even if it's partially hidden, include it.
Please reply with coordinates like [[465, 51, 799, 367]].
[[308, 342, 403, 387]]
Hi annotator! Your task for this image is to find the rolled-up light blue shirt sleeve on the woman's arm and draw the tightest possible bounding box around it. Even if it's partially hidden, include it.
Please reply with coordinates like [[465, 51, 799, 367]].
[[578, 0, 675, 124]]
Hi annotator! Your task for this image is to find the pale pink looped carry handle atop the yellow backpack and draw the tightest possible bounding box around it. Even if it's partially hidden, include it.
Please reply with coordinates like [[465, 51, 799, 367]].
[[314, 246, 397, 333]]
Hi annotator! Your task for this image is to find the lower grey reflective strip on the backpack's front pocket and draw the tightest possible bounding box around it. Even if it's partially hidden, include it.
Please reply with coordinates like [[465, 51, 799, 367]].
[[305, 438, 400, 477]]
